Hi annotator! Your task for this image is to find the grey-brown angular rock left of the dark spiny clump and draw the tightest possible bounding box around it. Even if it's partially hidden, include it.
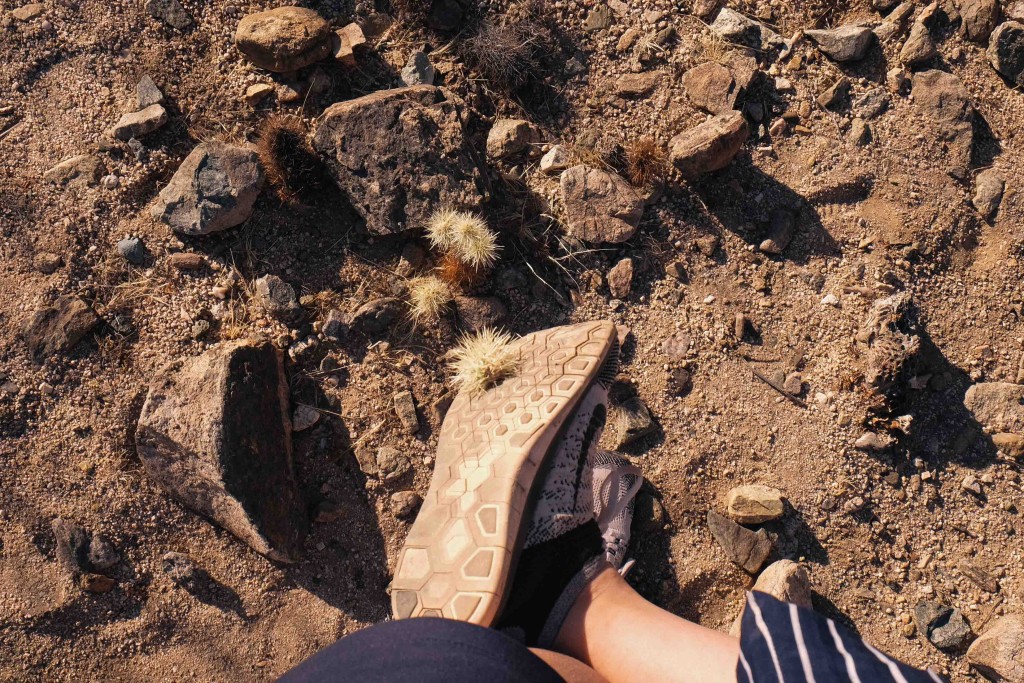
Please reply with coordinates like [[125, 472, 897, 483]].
[[151, 141, 264, 234]]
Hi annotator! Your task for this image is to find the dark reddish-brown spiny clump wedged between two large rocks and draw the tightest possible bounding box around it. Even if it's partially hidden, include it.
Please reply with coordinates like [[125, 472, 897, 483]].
[[256, 114, 323, 202]]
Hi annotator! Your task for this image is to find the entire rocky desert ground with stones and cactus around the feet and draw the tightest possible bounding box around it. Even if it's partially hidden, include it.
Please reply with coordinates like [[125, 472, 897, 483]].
[[0, 0, 1024, 681]]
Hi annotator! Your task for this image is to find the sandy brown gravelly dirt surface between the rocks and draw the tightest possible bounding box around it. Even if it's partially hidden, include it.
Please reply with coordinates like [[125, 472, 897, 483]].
[[0, 0, 1024, 681]]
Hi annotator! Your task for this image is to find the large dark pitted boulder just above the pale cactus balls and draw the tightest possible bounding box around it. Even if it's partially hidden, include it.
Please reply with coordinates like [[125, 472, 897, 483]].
[[313, 85, 480, 234]]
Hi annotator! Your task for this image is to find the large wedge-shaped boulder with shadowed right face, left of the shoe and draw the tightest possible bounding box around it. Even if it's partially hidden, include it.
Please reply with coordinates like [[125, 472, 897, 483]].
[[135, 340, 307, 561]]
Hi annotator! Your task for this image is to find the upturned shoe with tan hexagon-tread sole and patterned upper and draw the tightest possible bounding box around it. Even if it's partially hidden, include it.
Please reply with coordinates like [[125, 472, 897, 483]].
[[391, 321, 617, 626]]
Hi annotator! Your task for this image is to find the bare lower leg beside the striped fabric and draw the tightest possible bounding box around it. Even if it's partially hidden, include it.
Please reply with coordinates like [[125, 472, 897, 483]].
[[555, 567, 739, 683]]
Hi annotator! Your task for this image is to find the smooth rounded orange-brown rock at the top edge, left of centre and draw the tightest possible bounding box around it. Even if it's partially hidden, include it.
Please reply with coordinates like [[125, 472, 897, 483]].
[[234, 7, 331, 72]]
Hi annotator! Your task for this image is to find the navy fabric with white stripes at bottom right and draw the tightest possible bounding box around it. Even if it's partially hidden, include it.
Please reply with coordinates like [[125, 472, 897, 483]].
[[736, 593, 943, 683]]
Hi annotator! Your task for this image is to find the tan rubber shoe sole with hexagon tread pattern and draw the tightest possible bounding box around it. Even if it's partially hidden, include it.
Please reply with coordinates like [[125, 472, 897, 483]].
[[391, 321, 617, 626]]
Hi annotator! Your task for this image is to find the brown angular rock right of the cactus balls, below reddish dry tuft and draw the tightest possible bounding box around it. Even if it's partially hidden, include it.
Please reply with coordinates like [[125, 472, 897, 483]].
[[559, 165, 644, 244]]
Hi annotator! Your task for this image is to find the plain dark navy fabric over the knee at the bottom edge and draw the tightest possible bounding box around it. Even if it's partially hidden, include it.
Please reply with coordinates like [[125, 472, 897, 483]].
[[279, 617, 562, 683]]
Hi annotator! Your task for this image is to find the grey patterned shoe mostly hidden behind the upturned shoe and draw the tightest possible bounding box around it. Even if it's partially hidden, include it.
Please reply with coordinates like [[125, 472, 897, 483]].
[[593, 449, 643, 575]]
